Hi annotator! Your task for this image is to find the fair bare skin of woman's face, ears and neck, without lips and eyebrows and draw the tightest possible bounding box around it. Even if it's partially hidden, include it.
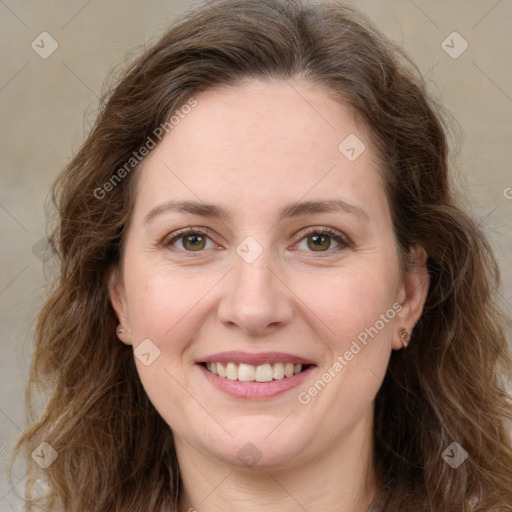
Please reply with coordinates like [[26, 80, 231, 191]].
[[110, 80, 428, 512]]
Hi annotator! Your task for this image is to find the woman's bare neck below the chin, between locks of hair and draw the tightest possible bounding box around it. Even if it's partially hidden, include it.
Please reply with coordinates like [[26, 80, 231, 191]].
[[175, 408, 377, 512]]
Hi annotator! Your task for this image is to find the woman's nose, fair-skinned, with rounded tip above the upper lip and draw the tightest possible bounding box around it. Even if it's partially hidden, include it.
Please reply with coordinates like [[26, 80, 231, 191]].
[[218, 251, 293, 337]]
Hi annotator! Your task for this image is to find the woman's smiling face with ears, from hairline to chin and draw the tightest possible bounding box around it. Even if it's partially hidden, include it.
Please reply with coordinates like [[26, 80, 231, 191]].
[[110, 81, 426, 468]]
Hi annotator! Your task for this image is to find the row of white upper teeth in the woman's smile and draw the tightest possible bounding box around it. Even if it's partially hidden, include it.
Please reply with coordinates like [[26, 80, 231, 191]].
[[206, 362, 302, 382]]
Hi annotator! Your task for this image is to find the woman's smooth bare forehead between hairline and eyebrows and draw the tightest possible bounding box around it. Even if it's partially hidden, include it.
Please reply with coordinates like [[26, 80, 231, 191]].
[[132, 80, 385, 222]]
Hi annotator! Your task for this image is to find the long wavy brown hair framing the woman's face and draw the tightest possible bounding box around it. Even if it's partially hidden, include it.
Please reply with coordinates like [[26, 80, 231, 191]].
[[11, 0, 512, 512]]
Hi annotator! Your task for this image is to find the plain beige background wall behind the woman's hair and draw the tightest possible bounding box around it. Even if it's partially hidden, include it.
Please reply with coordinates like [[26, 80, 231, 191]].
[[0, 0, 512, 511]]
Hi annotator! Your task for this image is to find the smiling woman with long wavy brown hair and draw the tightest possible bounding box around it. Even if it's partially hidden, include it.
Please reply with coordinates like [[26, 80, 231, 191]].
[[8, 0, 512, 512]]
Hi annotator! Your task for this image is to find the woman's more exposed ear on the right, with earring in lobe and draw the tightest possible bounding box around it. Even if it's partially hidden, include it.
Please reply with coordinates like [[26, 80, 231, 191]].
[[393, 246, 430, 350]]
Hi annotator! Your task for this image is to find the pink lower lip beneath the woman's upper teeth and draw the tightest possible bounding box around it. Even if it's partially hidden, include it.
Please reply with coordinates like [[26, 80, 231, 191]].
[[198, 364, 315, 400]]
